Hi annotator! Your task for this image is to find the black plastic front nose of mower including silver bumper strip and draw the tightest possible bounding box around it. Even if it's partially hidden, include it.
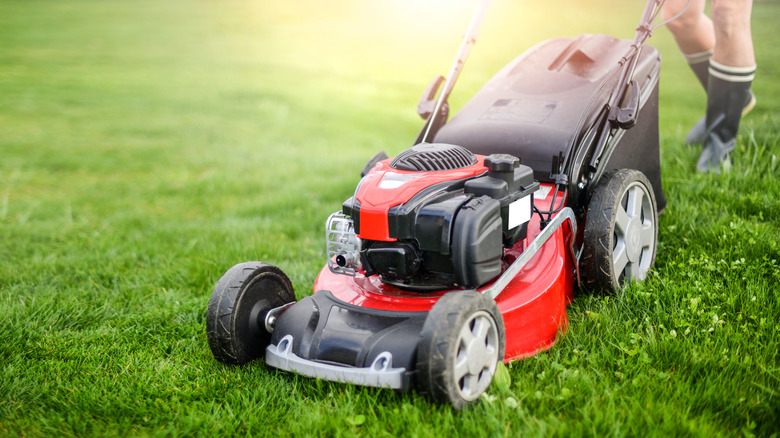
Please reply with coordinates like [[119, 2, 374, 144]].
[[265, 290, 428, 391]]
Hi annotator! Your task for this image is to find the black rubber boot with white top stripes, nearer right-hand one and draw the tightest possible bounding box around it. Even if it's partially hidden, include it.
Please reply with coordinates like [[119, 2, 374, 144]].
[[696, 60, 756, 173]]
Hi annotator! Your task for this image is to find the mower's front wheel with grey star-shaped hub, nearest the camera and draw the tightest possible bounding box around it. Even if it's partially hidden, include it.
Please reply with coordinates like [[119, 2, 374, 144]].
[[417, 291, 505, 409]]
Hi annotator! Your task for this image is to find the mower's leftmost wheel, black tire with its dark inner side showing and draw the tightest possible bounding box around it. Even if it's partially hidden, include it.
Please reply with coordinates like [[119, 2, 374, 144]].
[[206, 262, 295, 365]]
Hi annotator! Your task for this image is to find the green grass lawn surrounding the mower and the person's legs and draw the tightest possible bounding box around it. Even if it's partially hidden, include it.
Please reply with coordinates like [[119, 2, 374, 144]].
[[0, 0, 780, 436]]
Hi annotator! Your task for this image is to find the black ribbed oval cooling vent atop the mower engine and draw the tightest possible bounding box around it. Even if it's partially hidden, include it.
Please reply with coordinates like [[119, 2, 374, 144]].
[[390, 143, 477, 172]]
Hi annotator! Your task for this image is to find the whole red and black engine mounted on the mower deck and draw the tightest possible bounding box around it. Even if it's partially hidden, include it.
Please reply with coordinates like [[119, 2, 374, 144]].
[[326, 143, 539, 292]]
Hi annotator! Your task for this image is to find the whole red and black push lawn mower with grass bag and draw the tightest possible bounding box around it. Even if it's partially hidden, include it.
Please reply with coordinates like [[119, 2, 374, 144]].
[[207, 0, 666, 408]]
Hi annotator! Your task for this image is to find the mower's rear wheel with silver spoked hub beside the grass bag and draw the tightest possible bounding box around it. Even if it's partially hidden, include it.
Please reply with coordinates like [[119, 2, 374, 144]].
[[580, 169, 658, 293]]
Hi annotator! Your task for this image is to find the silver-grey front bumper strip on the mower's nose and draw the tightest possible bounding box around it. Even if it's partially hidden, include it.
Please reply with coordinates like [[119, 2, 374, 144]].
[[265, 335, 406, 390]]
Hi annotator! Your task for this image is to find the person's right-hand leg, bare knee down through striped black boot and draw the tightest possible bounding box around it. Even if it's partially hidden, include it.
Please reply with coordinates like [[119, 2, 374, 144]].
[[696, 0, 756, 172]]
